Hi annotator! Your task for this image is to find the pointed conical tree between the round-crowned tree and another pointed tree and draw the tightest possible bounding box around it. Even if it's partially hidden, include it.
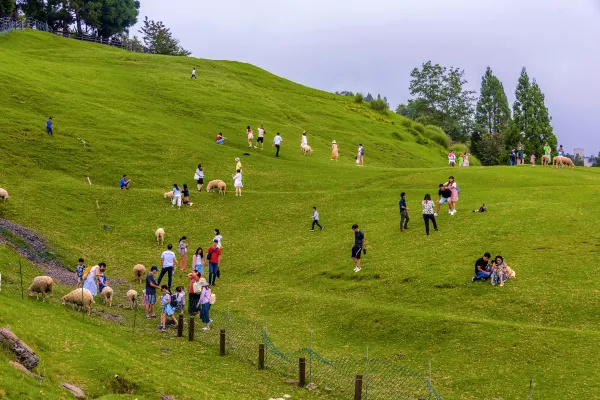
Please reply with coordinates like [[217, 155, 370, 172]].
[[471, 67, 511, 161]]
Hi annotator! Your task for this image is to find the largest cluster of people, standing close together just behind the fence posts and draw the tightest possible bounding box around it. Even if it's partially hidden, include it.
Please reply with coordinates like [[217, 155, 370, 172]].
[[143, 229, 223, 332]]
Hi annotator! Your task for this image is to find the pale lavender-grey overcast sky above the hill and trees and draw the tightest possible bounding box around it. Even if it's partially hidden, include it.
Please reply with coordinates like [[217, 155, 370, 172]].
[[136, 0, 600, 155]]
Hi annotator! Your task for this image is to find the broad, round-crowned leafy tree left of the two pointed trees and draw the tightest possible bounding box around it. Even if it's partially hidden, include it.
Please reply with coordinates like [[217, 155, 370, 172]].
[[409, 61, 475, 142]]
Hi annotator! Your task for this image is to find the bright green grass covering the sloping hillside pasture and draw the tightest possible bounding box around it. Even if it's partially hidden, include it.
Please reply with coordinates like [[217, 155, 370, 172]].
[[0, 32, 600, 400]]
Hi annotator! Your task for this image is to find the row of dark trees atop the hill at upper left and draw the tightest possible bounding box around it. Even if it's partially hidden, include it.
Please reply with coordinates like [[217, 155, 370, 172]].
[[0, 0, 191, 56]]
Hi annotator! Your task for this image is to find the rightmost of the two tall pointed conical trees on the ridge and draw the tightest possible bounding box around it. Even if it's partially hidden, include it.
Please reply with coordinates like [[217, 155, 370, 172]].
[[506, 68, 557, 157]]
